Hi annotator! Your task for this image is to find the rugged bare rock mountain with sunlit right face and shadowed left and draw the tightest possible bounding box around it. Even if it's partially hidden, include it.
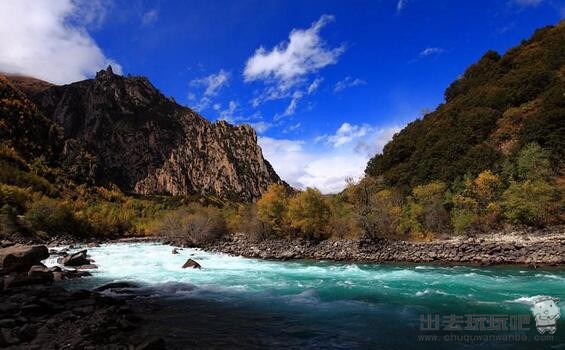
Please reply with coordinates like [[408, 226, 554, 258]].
[[14, 67, 281, 201]]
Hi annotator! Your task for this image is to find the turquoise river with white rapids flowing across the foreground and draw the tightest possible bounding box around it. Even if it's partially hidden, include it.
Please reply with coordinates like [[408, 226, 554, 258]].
[[47, 243, 565, 349]]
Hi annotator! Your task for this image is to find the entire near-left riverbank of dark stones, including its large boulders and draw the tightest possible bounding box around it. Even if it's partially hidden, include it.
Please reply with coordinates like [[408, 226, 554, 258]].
[[0, 242, 165, 350]]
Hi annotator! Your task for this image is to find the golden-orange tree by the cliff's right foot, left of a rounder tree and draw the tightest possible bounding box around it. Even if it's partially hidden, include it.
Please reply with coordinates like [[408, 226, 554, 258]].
[[257, 184, 288, 234]]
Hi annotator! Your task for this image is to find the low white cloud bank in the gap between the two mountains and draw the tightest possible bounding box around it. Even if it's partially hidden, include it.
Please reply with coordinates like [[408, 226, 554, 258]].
[[259, 123, 400, 193]]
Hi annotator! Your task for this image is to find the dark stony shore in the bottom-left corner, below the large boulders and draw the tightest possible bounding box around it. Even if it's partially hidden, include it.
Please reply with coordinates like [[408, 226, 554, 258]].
[[0, 285, 161, 350]]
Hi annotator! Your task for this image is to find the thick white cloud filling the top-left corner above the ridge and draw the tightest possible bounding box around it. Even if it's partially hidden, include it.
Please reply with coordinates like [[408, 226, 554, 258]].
[[0, 0, 122, 84]]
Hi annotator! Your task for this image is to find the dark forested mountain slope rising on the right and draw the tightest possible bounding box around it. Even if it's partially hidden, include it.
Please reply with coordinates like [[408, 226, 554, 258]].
[[365, 21, 565, 187]]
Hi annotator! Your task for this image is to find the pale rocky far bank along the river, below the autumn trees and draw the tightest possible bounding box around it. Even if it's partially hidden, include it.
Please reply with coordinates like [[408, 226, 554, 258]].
[[206, 226, 565, 267]]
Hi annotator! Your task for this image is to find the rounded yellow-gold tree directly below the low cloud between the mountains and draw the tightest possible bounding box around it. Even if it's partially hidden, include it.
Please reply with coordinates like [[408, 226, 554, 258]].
[[288, 188, 331, 239]]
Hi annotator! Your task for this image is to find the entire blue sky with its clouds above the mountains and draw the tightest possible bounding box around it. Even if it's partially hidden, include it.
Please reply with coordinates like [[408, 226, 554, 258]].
[[0, 0, 565, 193]]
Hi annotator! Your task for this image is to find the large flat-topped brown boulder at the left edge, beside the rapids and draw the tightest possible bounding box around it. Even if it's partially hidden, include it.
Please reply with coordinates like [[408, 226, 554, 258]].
[[0, 244, 49, 274]]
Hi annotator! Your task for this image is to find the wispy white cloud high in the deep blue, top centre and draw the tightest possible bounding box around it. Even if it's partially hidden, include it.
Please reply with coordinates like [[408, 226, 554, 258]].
[[243, 15, 345, 90]]
